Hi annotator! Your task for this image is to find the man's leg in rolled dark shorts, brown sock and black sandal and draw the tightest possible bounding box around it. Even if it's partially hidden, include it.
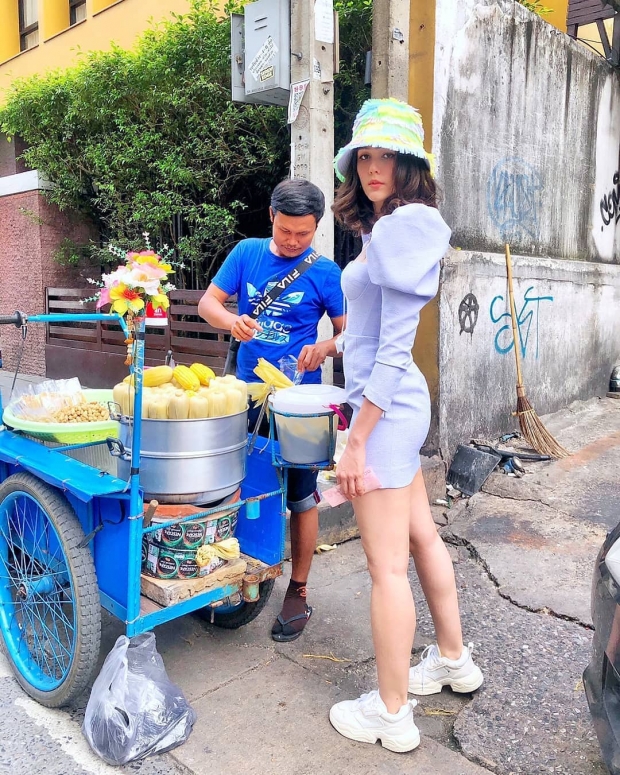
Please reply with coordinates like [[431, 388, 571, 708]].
[[271, 468, 319, 641]]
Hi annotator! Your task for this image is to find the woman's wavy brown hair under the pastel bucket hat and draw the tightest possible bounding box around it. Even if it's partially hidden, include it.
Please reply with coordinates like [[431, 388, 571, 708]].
[[332, 149, 437, 235]]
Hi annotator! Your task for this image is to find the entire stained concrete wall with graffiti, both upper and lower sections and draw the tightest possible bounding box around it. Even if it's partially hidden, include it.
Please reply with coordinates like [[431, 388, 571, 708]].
[[433, 0, 620, 457]]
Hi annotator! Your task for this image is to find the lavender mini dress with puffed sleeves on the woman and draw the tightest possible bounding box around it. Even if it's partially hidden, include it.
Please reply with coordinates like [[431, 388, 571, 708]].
[[340, 204, 450, 488]]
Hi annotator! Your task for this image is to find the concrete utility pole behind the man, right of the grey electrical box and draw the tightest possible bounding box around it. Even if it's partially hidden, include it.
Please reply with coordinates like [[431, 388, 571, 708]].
[[291, 0, 334, 383]]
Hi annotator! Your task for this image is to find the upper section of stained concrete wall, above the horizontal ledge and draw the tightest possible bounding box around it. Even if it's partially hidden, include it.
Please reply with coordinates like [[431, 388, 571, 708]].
[[434, 0, 620, 261]]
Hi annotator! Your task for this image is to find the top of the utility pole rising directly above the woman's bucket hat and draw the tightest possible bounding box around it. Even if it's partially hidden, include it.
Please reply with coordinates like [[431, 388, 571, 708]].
[[371, 0, 410, 102]]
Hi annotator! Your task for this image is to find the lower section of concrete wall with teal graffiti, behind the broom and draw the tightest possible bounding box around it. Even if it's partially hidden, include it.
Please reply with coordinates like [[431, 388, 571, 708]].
[[439, 250, 620, 459]]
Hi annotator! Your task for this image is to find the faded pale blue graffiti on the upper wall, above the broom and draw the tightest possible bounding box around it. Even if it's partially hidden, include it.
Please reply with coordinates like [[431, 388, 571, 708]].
[[487, 156, 542, 240]]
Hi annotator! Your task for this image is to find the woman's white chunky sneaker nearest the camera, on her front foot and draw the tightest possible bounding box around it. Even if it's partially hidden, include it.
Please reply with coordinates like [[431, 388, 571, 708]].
[[329, 689, 420, 753]]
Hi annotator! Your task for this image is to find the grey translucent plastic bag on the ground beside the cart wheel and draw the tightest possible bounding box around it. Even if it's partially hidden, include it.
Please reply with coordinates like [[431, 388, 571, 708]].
[[82, 632, 196, 764]]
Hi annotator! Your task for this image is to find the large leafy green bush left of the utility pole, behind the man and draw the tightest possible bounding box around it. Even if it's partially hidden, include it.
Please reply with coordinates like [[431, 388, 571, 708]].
[[0, 0, 289, 287]]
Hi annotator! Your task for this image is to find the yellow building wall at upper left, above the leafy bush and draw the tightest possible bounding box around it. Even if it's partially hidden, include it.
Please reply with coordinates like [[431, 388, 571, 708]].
[[0, 0, 224, 102]]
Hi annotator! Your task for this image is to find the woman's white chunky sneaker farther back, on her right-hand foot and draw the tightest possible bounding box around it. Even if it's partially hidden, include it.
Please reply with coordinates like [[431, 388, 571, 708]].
[[409, 643, 484, 694]]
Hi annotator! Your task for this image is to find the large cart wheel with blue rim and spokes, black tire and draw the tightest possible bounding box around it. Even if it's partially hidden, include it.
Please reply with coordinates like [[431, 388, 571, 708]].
[[0, 473, 101, 708]]
